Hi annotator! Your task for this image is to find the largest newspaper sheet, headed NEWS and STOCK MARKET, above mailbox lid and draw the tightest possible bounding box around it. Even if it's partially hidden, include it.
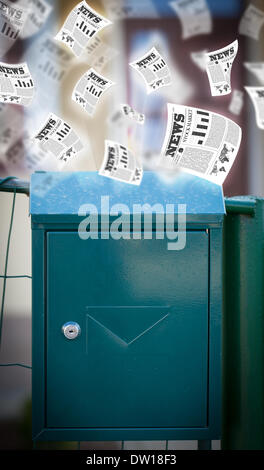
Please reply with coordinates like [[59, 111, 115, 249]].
[[159, 103, 241, 185]]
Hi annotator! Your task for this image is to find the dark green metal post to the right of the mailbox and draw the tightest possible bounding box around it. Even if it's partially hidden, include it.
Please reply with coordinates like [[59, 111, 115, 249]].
[[222, 197, 264, 450]]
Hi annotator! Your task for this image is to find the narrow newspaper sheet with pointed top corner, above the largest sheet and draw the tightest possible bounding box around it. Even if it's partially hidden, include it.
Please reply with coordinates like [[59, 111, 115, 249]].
[[205, 40, 238, 96]]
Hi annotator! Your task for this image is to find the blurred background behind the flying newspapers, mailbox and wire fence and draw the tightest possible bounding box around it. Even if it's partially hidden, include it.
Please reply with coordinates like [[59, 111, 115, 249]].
[[0, 0, 264, 449]]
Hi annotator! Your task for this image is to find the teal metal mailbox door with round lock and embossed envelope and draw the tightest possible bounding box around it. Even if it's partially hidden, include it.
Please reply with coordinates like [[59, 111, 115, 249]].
[[46, 231, 209, 428]]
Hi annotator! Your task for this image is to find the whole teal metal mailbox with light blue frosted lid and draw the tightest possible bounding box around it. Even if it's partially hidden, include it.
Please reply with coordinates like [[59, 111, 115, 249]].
[[30, 172, 225, 448]]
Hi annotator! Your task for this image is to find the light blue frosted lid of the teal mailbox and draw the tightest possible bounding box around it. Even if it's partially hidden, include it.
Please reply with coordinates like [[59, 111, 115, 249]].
[[30, 171, 225, 223]]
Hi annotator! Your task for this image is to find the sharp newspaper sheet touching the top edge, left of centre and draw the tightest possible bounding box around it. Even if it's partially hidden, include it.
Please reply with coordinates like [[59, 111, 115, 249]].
[[55, 1, 111, 57]]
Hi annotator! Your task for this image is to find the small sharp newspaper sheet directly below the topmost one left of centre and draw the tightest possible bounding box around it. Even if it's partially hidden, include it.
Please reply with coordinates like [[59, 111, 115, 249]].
[[72, 68, 114, 116]]
